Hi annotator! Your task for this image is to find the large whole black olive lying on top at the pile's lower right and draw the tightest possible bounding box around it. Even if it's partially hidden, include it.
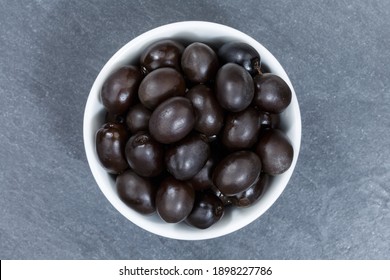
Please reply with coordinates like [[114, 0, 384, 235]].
[[213, 151, 261, 196]]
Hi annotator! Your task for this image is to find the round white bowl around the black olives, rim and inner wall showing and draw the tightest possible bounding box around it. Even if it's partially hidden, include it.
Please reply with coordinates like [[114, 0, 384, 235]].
[[84, 21, 301, 240]]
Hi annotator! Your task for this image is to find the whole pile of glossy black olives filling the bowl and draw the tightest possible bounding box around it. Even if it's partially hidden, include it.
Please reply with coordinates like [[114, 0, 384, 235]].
[[96, 39, 293, 229]]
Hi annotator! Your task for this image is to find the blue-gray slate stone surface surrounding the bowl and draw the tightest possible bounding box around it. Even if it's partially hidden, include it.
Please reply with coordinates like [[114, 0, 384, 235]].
[[0, 0, 390, 259]]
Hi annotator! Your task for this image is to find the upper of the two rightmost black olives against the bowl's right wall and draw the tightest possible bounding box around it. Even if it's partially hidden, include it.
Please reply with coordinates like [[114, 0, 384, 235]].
[[253, 73, 292, 114]]
